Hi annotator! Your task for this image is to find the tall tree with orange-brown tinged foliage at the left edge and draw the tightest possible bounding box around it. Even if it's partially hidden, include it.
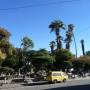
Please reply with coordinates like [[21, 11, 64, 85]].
[[0, 27, 15, 57]]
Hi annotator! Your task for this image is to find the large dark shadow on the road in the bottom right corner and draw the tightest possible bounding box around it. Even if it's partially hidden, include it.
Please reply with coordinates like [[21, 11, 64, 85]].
[[45, 84, 90, 90]]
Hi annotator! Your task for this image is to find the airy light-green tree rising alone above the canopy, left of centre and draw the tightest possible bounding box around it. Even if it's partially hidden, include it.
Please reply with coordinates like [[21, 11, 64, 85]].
[[21, 36, 34, 75]]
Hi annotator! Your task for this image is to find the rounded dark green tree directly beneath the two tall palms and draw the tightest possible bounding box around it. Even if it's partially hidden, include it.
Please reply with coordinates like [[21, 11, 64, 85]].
[[54, 49, 74, 70]]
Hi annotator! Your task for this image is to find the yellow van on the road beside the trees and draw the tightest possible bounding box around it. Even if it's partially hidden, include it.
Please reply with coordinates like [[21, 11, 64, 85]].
[[46, 71, 68, 83]]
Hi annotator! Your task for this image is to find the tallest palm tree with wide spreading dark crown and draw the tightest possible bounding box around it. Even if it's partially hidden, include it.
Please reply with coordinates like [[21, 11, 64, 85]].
[[49, 20, 65, 49]]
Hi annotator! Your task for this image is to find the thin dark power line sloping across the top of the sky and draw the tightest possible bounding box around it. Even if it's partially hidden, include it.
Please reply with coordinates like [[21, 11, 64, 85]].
[[0, 0, 80, 11]]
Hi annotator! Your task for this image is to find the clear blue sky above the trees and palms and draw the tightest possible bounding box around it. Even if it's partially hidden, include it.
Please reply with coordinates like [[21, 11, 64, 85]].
[[0, 0, 90, 56]]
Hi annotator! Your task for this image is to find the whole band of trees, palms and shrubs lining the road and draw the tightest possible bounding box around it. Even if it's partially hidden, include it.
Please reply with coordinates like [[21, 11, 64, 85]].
[[0, 20, 90, 81]]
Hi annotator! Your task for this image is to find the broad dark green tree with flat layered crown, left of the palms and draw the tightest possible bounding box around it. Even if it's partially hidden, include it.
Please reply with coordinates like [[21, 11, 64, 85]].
[[30, 49, 54, 71]]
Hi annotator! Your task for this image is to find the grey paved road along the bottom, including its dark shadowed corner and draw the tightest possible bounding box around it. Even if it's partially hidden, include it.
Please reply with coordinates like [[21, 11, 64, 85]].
[[0, 78, 90, 90]]
